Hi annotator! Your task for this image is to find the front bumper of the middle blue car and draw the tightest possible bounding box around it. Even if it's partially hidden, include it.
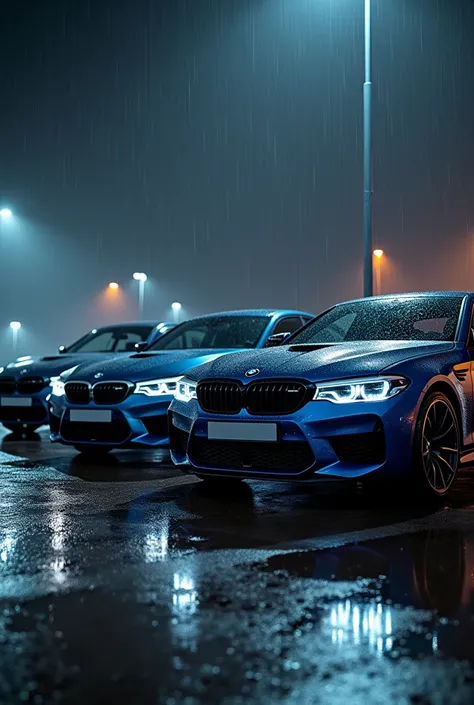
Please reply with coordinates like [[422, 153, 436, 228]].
[[48, 394, 172, 448]]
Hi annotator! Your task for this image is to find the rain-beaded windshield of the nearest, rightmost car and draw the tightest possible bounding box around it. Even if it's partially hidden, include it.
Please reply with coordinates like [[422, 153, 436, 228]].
[[291, 296, 463, 345]]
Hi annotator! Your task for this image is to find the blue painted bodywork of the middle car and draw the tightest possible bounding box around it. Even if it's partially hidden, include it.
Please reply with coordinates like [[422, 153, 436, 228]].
[[49, 309, 314, 449]]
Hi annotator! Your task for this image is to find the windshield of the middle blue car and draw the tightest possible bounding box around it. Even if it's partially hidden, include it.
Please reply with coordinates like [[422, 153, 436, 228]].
[[148, 316, 269, 350]]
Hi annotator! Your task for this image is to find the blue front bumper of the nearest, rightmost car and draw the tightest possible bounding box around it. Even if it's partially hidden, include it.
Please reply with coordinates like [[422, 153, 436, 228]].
[[169, 388, 419, 481]]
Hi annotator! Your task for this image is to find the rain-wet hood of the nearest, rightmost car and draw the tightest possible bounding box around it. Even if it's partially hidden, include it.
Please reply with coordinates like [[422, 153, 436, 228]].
[[186, 341, 454, 383]]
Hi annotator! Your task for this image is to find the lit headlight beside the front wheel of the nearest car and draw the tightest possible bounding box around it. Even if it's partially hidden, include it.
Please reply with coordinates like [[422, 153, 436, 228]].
[[313, 377, 409, 404]]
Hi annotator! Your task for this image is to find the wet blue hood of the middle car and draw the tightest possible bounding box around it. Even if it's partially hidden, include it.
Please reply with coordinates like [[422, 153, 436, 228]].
[[64, 350, 228, 382]]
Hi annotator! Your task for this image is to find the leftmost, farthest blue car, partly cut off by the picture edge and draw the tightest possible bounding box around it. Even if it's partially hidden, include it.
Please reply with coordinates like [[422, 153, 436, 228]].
[[0, 321, 174, 433]]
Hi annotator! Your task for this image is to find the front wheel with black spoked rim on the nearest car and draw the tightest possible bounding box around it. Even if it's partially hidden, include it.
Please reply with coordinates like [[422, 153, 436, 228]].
[[411, 392, 461, 499]]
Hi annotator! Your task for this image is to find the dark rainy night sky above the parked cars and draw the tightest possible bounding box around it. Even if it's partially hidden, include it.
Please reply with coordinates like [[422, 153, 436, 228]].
[[0, 0, 474, 355]]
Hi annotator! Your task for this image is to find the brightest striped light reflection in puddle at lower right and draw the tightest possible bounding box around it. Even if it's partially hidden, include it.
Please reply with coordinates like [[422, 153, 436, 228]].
[[323, 600, 438, 655]]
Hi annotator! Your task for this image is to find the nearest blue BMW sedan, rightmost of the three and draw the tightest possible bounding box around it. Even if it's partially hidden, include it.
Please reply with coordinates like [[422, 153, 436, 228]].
[[169, 292, 474, 496]]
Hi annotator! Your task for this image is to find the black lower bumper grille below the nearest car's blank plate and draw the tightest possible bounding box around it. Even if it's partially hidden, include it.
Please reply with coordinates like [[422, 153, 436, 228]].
[[188, 436, 314, 473]]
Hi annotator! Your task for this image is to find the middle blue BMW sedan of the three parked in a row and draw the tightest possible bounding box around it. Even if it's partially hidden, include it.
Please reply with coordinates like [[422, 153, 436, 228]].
[[49, 310, 314, 454]]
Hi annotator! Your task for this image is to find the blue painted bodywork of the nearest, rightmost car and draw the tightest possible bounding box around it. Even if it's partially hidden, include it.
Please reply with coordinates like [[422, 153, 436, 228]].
[[170, 292, 474, 481]]
